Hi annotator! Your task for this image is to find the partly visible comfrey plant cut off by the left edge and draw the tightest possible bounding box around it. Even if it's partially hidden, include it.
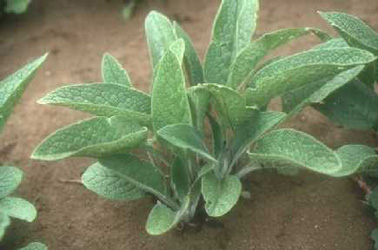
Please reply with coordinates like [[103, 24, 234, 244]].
[[0, 55, 47, 250]]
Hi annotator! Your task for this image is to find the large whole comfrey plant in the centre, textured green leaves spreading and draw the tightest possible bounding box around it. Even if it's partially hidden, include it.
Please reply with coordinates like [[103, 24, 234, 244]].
[[32, 0, 376, 235]]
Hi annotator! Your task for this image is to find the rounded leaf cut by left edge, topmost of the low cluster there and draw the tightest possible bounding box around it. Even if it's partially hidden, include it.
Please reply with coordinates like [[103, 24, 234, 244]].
[[0, 166, 22, 199]]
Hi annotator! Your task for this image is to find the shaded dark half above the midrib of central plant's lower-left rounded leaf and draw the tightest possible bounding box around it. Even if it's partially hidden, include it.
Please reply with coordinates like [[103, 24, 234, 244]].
[[99, 155, 166, 205]]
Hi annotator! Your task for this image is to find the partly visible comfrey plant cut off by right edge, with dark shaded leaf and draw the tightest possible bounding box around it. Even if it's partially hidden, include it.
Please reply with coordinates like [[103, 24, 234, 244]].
[[302, 12, 378, 249]]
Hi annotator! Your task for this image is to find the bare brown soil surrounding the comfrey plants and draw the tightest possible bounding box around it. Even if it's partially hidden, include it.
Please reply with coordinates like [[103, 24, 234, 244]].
[[0, 0, 378, 250]]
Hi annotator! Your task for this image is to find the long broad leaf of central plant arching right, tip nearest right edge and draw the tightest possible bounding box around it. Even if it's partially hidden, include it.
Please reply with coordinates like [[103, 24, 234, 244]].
[[247, 48, 376, 106]]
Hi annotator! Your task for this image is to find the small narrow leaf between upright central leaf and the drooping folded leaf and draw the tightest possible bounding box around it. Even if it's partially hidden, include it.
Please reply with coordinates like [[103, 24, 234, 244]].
[[188, 87, 210, 132]]
